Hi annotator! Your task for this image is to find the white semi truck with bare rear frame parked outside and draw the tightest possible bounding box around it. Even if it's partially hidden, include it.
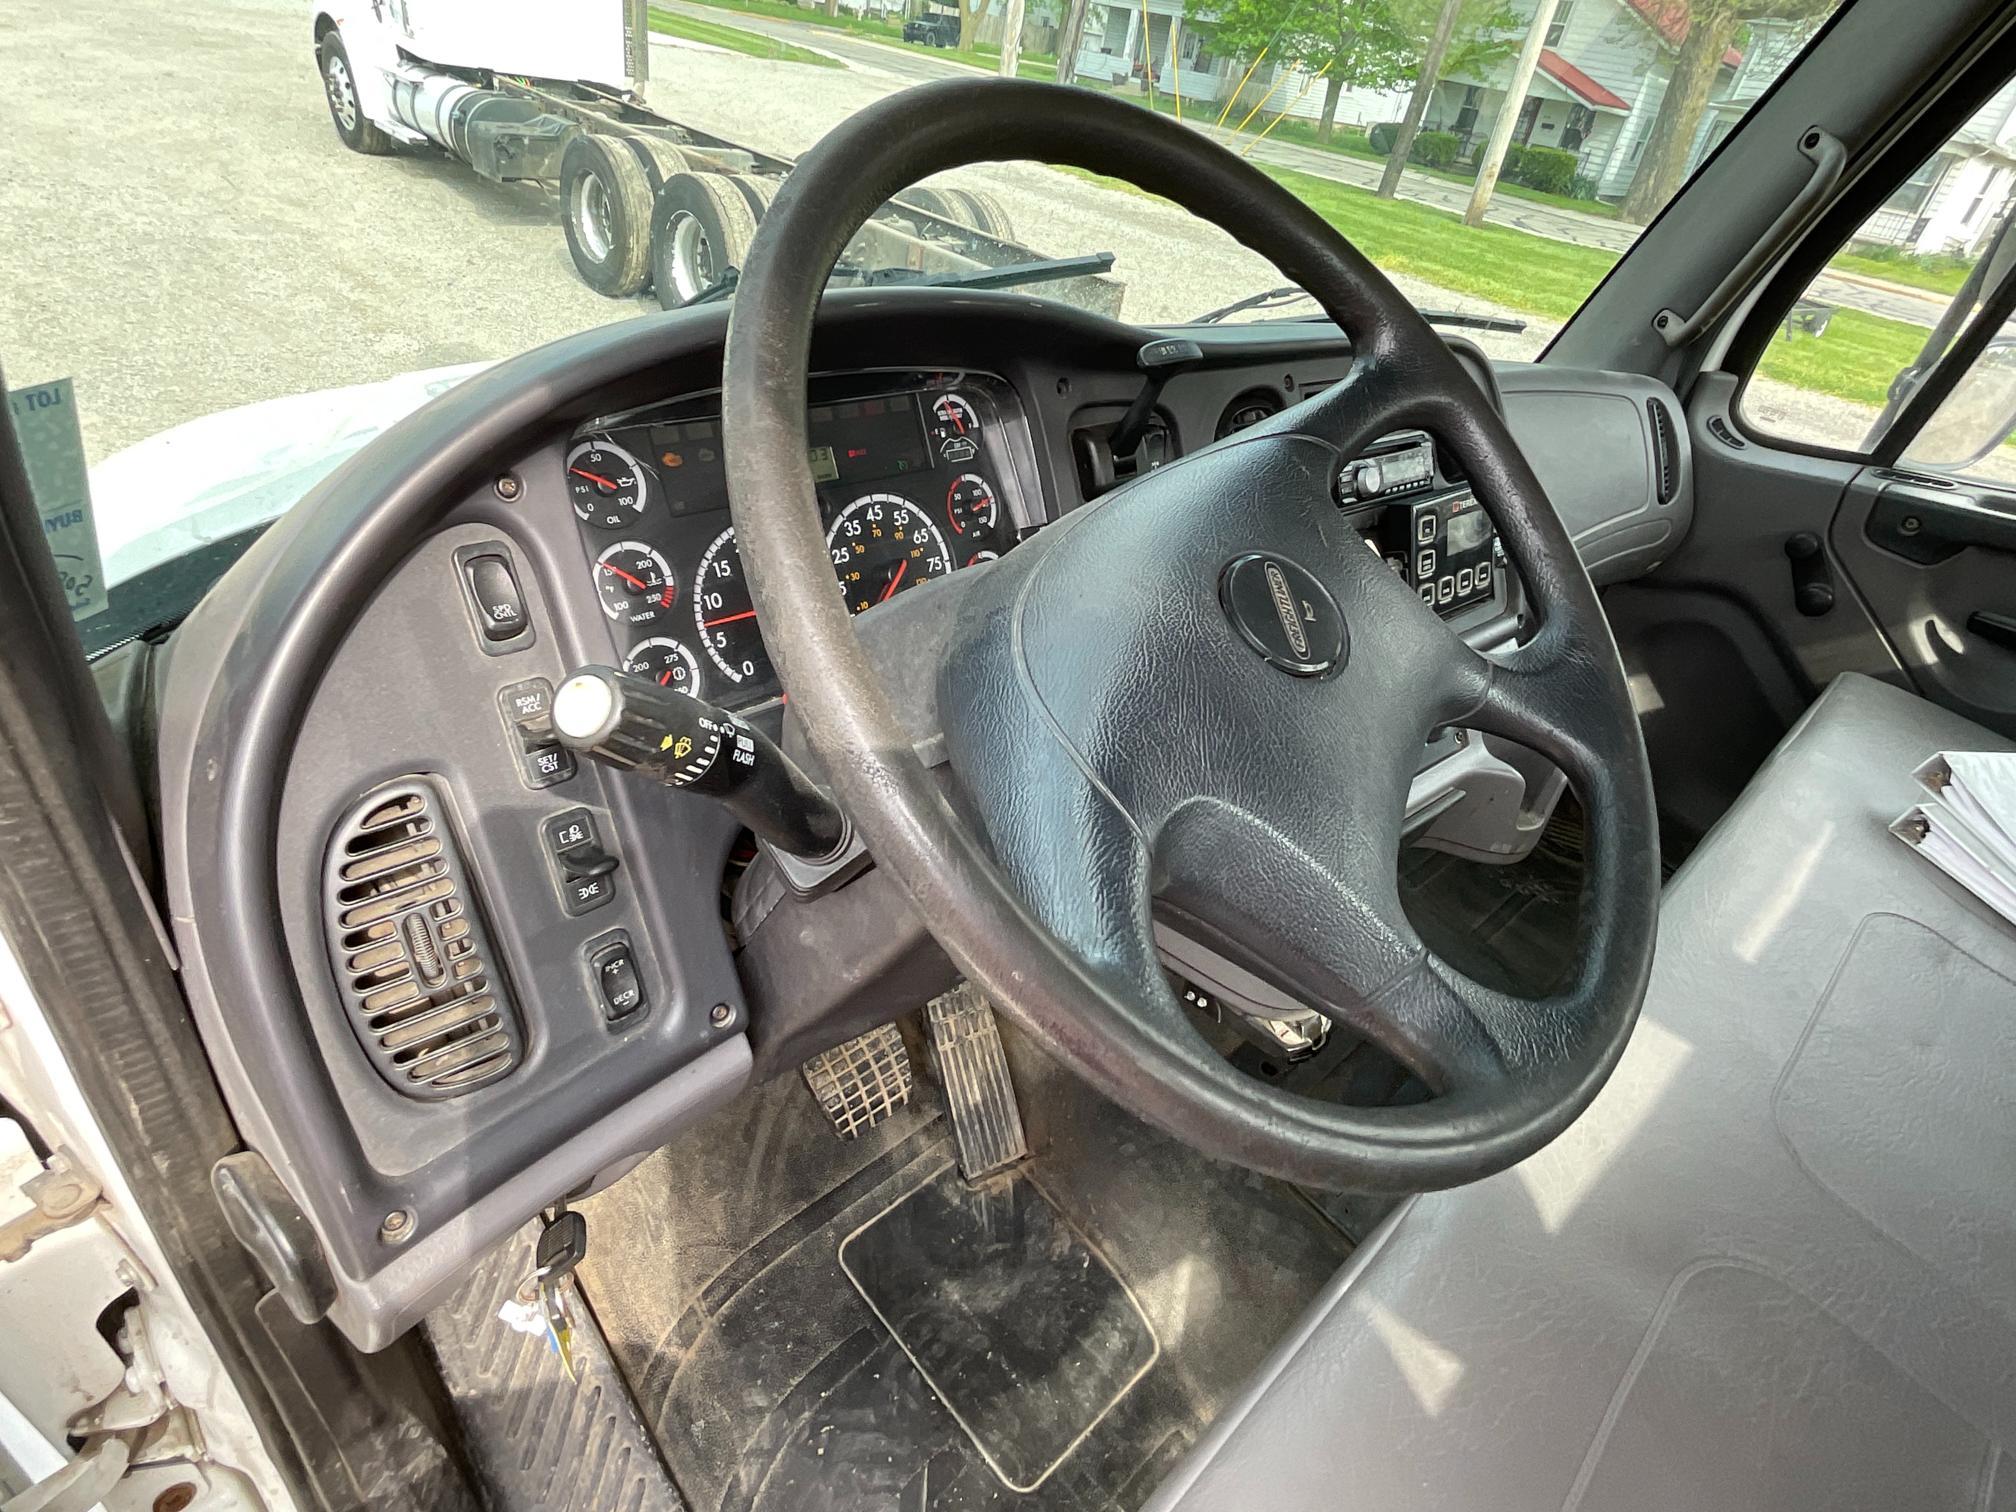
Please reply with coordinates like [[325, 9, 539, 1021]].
[[310, 0, 1123, 314]]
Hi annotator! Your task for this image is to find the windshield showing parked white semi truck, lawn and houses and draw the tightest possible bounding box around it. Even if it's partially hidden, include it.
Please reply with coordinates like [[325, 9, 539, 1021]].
[[0, 0, 1846, 641]]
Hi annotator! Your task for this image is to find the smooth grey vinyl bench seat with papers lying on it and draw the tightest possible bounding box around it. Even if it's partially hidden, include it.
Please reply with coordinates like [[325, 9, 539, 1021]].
[[1149, 677, 2016, 1512]]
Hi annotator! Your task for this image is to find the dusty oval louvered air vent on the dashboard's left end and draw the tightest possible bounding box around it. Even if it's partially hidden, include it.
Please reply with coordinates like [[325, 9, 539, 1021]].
[[323, 778, 520, 1099]]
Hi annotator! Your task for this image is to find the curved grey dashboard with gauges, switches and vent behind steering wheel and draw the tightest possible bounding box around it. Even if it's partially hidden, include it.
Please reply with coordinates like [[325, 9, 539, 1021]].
[[153, 288, 1691, 1349]]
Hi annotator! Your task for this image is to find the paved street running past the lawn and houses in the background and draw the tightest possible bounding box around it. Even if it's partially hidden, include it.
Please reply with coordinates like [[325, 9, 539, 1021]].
[[669, 0, 1945, 327]]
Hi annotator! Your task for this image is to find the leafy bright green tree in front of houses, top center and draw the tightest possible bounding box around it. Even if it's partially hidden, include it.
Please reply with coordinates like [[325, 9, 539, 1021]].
[[1187, 0, 1421, 141]]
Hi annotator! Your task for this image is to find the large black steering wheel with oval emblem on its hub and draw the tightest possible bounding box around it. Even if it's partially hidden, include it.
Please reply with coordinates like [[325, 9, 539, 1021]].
[[724, 81, 1659, 1191]]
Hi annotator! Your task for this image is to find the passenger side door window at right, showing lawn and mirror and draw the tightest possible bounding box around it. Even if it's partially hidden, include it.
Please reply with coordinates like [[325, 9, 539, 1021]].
[[1742, 83, 2016, 484]]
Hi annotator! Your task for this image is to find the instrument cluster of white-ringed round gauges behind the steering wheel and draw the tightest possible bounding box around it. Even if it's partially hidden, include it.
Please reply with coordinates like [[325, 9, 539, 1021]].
[[566, 373, 1040, 710]]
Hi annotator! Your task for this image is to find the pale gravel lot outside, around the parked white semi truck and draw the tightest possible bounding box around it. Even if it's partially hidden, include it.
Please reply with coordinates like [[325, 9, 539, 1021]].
[[0, 0, 1919, 460]]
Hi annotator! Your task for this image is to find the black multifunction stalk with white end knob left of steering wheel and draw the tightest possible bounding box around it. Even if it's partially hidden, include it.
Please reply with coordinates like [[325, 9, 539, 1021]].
[[552, 667, 847, 859]]
